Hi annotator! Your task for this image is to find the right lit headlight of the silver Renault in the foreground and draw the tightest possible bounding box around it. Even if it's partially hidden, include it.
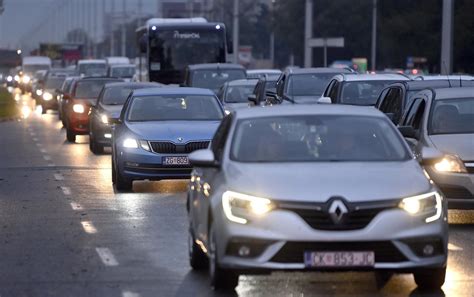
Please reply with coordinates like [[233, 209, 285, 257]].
[[399, 192, 443, 223]]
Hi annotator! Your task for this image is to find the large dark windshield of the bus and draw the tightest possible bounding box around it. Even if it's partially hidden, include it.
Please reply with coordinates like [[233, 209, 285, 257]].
[[150, 28, 225, 71]]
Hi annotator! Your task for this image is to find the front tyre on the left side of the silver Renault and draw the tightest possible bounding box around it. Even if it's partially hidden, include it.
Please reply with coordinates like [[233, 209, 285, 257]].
[[209, 223, 239, 291]]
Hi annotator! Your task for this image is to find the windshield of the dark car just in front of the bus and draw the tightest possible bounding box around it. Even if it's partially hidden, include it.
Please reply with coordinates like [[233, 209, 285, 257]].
[[192, 69, 246, 90]]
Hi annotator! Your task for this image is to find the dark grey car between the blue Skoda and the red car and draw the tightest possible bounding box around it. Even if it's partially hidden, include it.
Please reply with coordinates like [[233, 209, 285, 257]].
[[89, 82, 162, 154]]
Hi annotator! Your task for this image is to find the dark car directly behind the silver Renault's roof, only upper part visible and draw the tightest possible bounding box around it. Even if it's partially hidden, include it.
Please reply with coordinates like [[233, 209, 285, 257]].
[[265, 68, 351, 105]]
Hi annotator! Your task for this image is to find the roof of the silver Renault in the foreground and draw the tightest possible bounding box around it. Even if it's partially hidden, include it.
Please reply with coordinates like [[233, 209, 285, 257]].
[[234, 104, 384, 119]]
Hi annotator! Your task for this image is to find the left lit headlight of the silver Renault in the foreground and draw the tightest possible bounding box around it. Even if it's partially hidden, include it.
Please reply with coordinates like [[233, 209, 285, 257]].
[[222, 191, 275, 224]]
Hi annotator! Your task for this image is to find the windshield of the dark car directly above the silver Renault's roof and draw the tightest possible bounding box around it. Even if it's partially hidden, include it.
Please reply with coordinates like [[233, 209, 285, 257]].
[[286, 73, 335, 100]]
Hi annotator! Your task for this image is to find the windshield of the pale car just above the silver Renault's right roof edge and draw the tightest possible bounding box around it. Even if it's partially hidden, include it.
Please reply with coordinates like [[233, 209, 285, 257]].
[[341, 80, 394, 105]]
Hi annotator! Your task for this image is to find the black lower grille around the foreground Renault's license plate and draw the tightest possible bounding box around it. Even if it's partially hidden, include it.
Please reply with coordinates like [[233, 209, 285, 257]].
[[270, 241, 407, 263]]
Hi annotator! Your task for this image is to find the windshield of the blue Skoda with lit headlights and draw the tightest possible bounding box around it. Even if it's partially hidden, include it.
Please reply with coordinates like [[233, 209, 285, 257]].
[[128, 95, 223, 122]]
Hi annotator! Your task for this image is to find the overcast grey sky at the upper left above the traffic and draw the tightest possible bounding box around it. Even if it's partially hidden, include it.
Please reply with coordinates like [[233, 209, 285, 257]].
[[0, 0, 158, 48]]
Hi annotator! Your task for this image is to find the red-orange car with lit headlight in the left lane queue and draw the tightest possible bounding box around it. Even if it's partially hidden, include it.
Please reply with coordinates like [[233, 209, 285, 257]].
[[62, 77, 123, 142]]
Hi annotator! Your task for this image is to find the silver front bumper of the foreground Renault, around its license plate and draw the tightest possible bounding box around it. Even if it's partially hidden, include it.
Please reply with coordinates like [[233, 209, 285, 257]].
[[214, 205, 448, 273]]
